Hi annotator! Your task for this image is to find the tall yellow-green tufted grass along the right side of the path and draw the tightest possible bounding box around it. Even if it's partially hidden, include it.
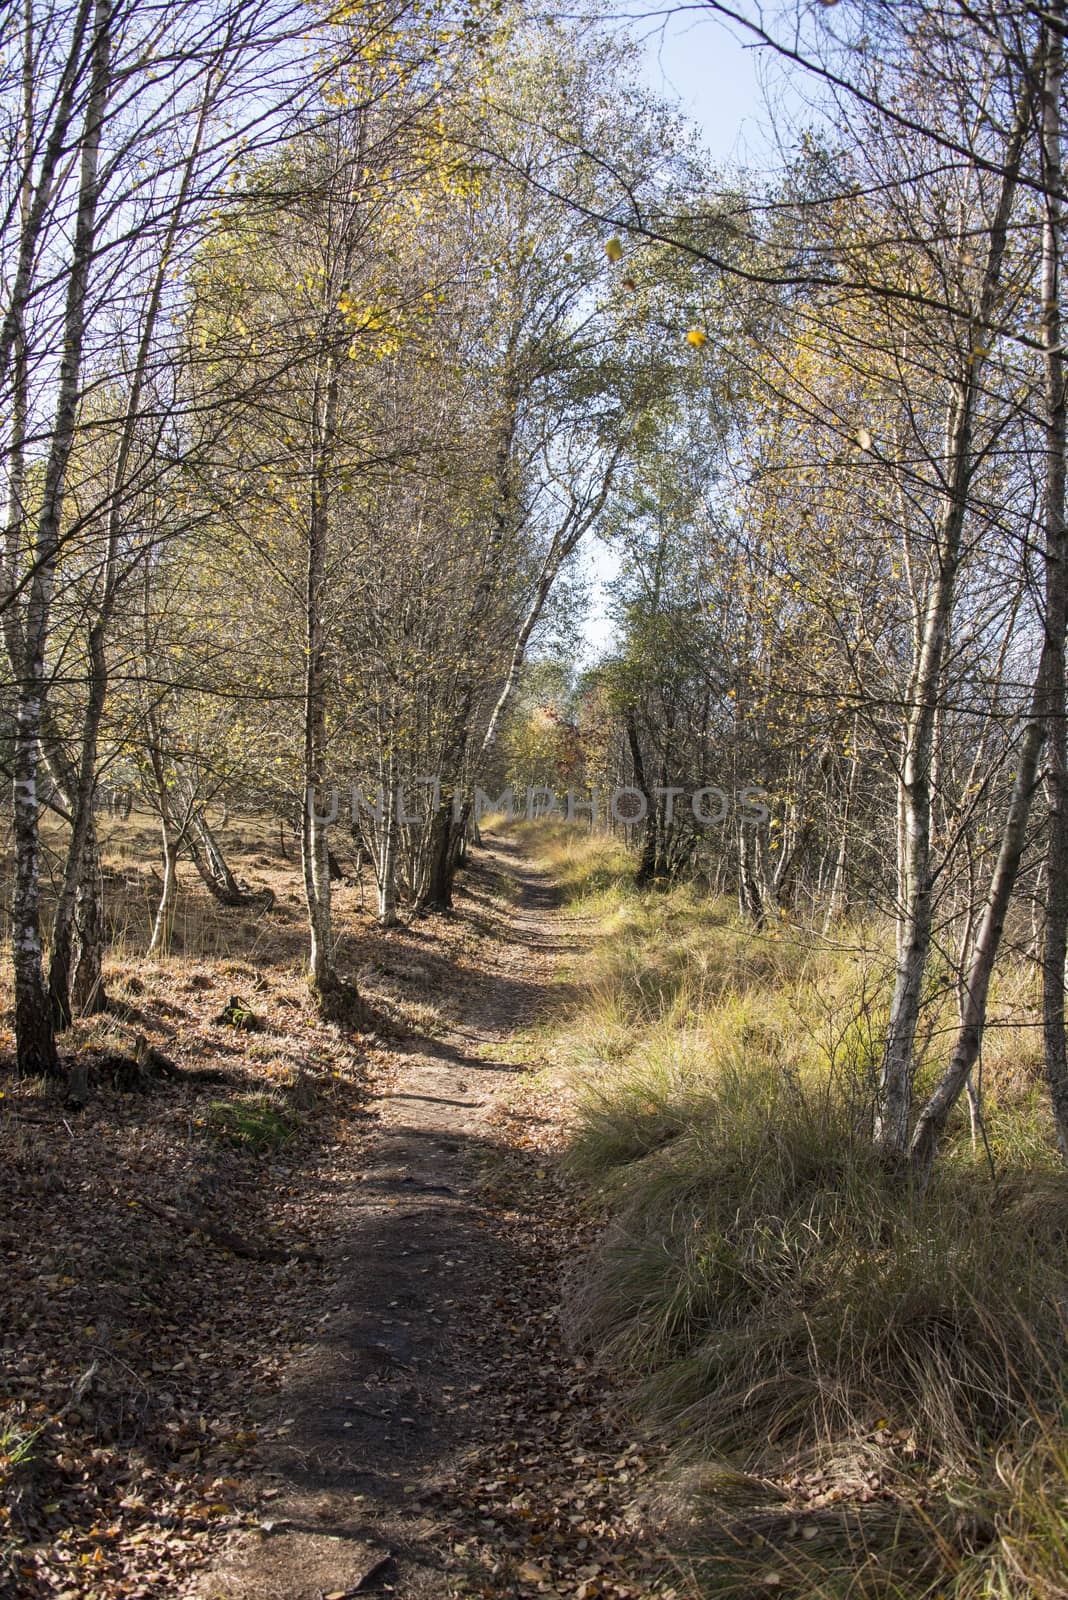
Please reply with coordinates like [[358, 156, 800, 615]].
[[530, 832, 1068, 1600]]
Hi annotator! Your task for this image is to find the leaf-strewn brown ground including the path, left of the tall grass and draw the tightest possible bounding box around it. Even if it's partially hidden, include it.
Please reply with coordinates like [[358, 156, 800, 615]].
[[0, 838, 681, 1600]]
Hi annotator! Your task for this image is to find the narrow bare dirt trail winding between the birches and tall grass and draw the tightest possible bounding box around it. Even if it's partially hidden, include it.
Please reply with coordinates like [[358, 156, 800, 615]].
[[197, 842, 620, 1600]]
